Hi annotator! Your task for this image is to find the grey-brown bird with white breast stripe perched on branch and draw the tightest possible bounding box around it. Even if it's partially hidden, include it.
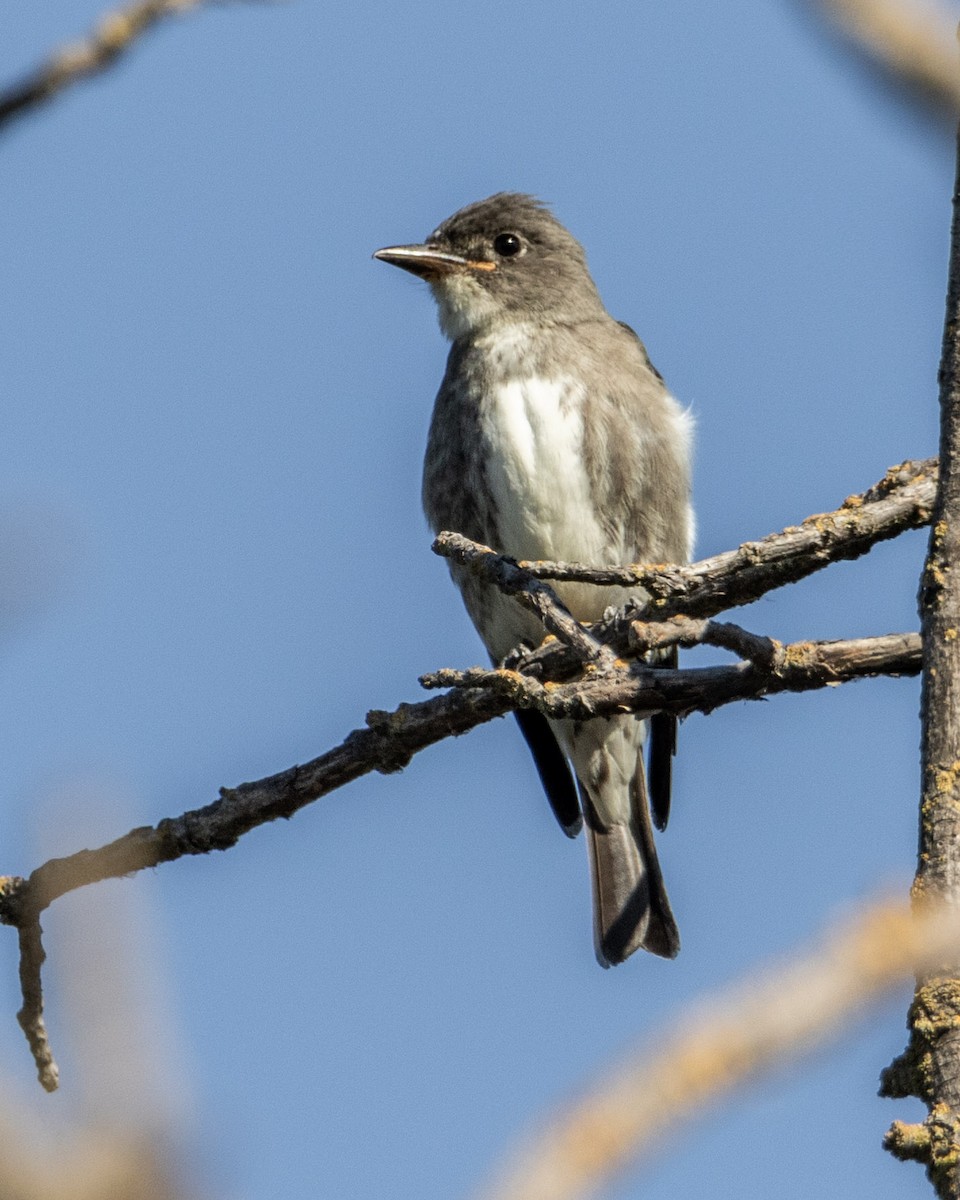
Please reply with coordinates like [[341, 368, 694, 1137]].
[[373, 192, 694, 967]]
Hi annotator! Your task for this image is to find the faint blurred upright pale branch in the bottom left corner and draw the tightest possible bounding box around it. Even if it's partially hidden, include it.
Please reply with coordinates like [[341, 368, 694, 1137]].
[[0, 775, 204, 1200]]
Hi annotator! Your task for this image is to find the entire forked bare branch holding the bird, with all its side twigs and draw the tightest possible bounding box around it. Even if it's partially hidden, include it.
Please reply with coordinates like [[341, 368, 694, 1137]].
[[0, 462, 934, 1087]]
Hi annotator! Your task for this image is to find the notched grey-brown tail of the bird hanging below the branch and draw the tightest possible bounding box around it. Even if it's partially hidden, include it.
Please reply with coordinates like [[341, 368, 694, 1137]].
[[581, 760, 680, 967]]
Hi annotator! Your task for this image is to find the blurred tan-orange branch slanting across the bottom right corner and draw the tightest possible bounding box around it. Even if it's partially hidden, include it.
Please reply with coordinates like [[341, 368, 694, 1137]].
[[478, 901, 960, 1200]]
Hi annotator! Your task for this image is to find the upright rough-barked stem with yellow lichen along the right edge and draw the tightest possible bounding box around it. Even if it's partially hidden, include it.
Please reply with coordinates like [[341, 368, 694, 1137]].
[[881, 117, 960, 1200]]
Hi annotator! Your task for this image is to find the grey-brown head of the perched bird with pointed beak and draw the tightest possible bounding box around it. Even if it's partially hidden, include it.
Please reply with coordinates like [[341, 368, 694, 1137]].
[[373, 192, 604, 340]]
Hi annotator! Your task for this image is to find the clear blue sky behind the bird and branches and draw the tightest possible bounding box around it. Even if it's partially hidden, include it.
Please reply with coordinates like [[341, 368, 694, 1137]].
[[0, 0, 953, 1200]]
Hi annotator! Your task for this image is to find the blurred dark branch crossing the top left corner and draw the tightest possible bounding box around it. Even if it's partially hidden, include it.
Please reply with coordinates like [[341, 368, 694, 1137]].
[[0, 0, 219, 127]]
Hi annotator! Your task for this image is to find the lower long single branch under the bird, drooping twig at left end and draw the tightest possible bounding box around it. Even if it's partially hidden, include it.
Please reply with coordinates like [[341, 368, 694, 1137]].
[[0, 634, 920, 1087]]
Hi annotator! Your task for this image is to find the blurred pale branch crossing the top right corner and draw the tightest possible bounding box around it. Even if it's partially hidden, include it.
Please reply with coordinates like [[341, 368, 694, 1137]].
[[804, 0, 960, 121]]
